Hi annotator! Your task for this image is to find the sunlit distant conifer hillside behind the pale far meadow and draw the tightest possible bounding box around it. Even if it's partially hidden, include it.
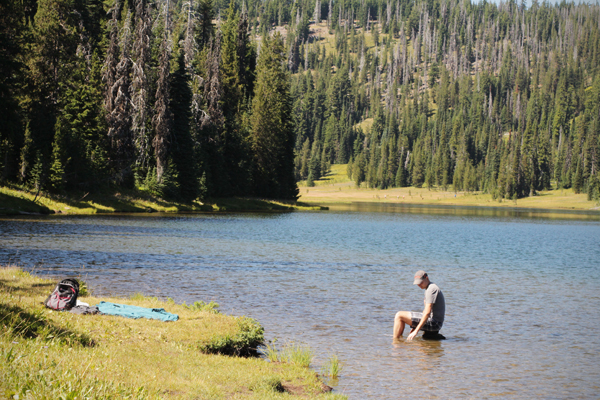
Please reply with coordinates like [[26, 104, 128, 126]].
[[288, 0, 600, 199]]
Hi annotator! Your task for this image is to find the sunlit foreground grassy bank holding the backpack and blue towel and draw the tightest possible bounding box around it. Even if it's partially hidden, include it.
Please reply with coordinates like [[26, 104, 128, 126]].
[[0, 267, 345, 399]]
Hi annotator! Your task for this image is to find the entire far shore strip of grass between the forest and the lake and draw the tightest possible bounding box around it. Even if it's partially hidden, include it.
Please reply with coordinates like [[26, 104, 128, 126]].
[[0, 165, 600, 216]]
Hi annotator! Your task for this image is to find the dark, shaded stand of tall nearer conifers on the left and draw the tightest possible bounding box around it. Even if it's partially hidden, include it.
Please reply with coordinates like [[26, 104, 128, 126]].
[[0, 0, 297, 201]]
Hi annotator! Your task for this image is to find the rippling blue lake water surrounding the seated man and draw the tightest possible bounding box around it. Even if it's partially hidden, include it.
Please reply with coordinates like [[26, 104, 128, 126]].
[[0, 205, 600, 399]]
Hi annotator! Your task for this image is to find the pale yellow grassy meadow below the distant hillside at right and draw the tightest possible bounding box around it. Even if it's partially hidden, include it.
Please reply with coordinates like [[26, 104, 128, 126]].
[[299, 165, 600, 212]]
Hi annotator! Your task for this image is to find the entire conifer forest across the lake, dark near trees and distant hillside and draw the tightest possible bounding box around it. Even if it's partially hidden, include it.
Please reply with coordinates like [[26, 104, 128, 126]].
[[0, 0, 600, 201]]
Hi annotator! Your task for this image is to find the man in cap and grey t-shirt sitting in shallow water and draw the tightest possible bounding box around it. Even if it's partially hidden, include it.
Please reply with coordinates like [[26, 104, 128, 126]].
[[394, 271, 446, 341]]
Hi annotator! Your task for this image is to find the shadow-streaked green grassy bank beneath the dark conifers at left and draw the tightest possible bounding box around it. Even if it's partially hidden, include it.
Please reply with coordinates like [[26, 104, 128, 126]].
[[0, 186, 321, 215]]
